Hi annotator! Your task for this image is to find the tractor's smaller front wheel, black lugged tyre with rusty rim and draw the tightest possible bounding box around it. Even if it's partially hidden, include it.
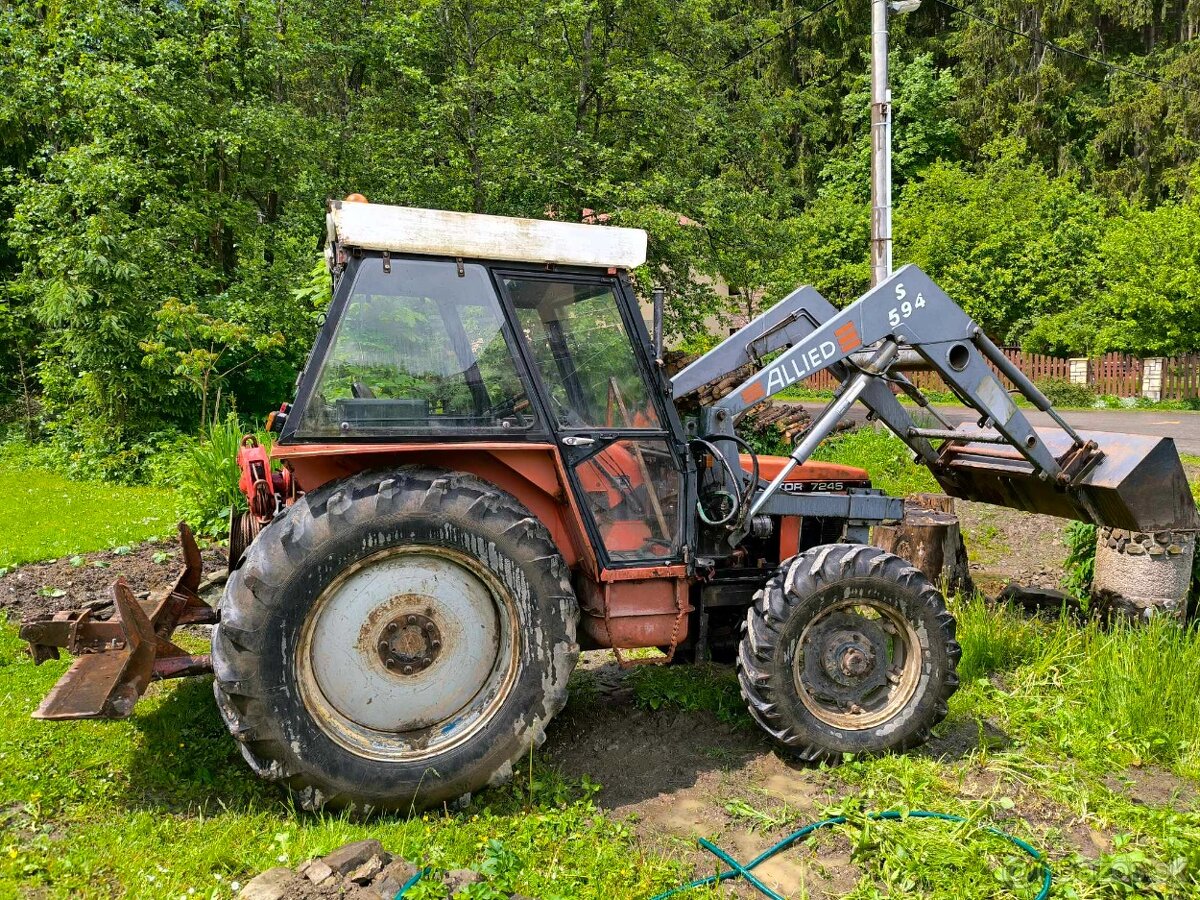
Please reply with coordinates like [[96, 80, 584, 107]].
[[738, 544, 961, 762]]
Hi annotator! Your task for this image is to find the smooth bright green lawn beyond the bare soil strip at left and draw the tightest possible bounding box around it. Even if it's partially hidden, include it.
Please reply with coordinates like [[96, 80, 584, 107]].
[[0, 464, 176, 568]]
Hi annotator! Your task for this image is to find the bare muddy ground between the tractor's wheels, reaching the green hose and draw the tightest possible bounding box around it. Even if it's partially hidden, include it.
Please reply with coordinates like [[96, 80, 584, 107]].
[[544, 653, 860, 898]]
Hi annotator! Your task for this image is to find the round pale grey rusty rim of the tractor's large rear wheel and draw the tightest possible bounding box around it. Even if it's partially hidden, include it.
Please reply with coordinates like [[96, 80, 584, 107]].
[[296, 545, 520, 762]]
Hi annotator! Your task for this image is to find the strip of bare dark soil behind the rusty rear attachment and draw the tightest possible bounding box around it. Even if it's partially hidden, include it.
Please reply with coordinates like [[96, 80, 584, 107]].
[[0, 541, 226, 622]]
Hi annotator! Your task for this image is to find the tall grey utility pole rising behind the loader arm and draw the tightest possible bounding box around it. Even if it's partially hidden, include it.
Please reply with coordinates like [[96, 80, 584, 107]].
[[871, 0, 920, 286]]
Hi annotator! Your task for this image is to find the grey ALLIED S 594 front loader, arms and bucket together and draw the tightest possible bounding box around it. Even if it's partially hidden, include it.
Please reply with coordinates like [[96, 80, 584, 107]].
[[672, 265, 1200, 540]]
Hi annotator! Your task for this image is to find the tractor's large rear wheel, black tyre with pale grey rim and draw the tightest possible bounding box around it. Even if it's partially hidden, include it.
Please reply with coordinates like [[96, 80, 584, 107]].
[[212, 467, 578, 811]]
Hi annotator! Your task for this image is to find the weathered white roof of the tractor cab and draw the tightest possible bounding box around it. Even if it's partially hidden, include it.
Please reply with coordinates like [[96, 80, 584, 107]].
[[328, 200, 646, 269]]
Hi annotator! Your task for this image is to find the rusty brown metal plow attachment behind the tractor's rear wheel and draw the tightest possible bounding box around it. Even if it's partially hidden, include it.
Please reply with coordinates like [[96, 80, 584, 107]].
[[20, 523, 217, 719]]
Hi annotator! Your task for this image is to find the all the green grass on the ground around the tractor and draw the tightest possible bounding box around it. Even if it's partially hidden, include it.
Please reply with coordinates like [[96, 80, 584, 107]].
[[0, 458, 1200, 900]]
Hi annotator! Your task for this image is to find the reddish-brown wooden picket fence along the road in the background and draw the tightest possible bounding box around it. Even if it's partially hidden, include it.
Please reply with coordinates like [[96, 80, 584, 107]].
[[806, 347, 1200, 400]]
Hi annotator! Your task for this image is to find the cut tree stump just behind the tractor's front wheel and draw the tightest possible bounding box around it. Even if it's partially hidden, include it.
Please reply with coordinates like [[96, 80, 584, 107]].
[[871, 493, 974, 594]]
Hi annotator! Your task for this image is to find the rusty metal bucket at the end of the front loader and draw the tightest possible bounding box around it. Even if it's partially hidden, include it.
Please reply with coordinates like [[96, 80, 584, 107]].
[[935, 426, 1200, 532]]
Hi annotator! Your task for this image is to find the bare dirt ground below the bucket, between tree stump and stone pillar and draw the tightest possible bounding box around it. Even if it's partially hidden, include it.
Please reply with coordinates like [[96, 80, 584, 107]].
[[955, 500, 1067, 596]]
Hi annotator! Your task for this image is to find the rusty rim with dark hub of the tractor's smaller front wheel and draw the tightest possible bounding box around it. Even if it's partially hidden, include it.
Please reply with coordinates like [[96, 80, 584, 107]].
[[792, 596, 924, 731]]
